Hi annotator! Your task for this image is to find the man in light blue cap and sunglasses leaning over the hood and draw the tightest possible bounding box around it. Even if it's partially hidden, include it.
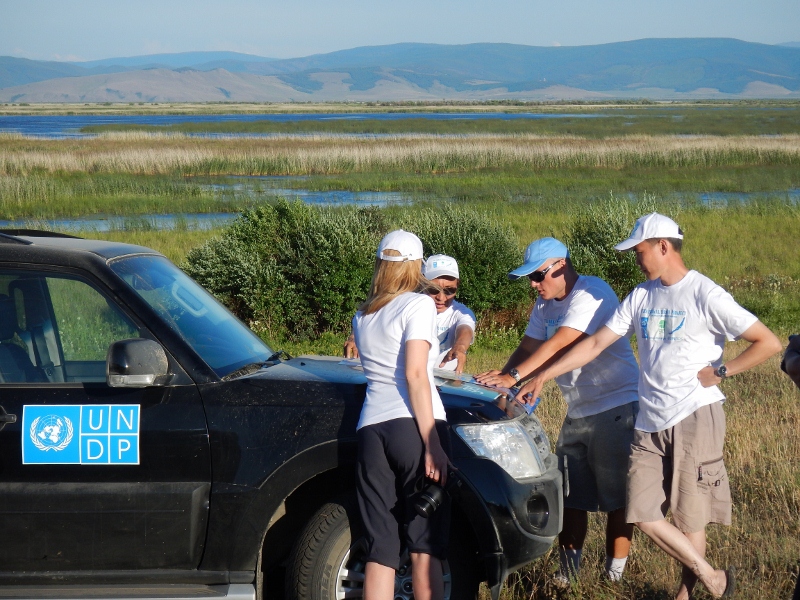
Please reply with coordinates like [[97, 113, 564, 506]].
[[476, 238, 639, 587]]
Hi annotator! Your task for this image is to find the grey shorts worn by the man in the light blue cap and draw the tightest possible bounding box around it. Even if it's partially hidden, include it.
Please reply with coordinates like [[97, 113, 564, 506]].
[[556, 402, 639, 512]]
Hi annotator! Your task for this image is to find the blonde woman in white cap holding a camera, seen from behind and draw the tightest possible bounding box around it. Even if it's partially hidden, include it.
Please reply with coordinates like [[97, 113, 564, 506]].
[[353, 230, 450, 600]]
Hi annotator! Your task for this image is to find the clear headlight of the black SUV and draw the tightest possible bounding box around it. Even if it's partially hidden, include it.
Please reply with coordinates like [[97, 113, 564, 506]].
[[455, 421, 545, 480]]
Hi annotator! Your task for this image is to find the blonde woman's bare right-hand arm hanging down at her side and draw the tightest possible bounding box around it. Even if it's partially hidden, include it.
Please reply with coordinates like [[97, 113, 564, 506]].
[[406, 340, 447, 485]]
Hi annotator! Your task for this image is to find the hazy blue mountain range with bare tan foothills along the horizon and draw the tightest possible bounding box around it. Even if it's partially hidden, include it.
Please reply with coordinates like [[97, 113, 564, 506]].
[[0, 38, 800, 103]]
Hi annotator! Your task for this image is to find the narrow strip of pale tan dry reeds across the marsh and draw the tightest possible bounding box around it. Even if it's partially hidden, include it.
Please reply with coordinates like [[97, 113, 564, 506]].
[[0, 134, 800, 176]]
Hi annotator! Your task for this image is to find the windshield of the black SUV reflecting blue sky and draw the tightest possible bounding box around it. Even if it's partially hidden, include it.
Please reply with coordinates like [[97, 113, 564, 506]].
[[110, 256, 273, 377]]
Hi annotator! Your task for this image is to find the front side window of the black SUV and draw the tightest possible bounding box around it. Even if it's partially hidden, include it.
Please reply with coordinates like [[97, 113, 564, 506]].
[[0, 271, 139, 383]]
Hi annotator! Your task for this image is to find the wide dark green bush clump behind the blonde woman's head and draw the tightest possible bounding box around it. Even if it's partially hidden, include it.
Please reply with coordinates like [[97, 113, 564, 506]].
[[184, 200, 529, 342]]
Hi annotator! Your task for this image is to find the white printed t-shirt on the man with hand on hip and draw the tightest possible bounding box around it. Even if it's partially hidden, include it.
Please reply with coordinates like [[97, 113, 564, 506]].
[[606, 271, 758, 432]]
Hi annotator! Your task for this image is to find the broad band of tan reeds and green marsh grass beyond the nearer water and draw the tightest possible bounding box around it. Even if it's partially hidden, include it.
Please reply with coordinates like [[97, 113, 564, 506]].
[[0, 133, 800, 219]]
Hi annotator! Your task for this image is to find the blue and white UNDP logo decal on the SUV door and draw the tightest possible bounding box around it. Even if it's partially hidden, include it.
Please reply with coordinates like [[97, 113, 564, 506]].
[[22, 404, 139, 465]]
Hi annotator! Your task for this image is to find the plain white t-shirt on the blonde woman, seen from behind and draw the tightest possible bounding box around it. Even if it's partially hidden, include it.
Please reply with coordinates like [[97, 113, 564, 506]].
[[353, 292, 446, 429]]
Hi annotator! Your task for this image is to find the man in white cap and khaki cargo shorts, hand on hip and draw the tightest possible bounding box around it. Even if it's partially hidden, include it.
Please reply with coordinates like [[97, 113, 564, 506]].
[[520, 213, 781, 600]]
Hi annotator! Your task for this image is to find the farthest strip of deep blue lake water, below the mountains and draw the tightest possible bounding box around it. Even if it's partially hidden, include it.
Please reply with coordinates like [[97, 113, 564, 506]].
[[0, 112, 604, 138]]
